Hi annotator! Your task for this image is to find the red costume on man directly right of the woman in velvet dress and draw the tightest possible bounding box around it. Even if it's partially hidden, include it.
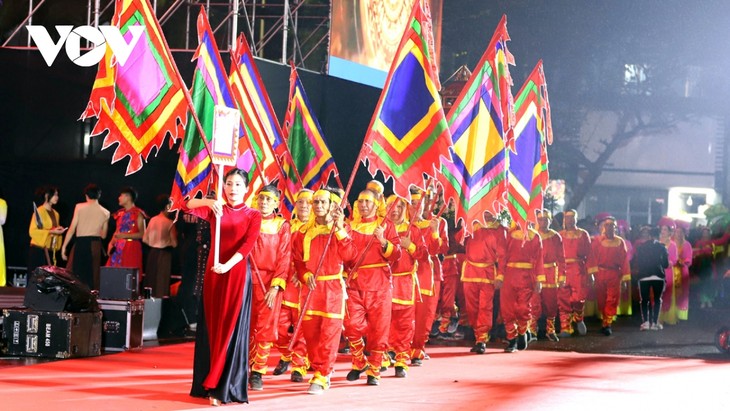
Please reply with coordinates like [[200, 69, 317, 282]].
[[249, 213, 291, 374]]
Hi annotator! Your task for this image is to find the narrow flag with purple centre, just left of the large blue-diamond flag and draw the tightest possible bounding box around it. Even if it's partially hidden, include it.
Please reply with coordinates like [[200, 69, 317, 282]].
[[284, 65, 342, 190]]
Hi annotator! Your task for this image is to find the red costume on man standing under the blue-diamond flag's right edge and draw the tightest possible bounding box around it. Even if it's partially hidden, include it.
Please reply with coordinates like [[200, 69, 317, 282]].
[[411, 218, 444, 360]]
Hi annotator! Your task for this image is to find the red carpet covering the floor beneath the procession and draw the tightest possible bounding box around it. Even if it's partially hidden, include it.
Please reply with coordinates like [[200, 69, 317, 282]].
[[0, 343, 730, 411]]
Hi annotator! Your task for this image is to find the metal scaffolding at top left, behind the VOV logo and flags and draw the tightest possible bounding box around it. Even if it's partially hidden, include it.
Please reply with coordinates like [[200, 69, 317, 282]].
[[2, 0, 331, 71]]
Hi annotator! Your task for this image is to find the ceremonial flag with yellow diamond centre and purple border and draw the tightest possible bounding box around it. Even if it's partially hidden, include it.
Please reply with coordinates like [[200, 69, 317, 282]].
[[439, 17, 511, 231]]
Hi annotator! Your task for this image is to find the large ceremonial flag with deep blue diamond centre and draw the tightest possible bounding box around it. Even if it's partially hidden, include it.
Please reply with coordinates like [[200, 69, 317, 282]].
[[353, 0, 451, 198]]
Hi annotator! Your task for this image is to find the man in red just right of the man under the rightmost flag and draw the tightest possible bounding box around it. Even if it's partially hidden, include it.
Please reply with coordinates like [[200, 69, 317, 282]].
[[530, 209, 565, 342]]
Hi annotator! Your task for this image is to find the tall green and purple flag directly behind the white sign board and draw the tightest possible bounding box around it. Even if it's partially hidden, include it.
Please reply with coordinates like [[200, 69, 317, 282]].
[[171, 7, 237, 209]]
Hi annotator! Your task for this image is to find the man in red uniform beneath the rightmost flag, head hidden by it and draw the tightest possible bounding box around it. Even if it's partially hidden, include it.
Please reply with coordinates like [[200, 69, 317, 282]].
[[497, 227, 545, 352]]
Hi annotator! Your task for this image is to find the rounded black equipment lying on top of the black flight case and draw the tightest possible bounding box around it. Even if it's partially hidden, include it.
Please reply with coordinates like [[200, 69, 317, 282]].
[[23, 265, 99, 312]]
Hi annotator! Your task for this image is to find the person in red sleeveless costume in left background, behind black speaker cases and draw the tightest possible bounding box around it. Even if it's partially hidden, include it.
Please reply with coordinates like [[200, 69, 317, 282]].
[[106, 187, 147, 278]]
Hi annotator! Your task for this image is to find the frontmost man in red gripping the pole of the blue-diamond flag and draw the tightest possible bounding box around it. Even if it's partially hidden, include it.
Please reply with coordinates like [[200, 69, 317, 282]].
[[292, 188, 358, 395]]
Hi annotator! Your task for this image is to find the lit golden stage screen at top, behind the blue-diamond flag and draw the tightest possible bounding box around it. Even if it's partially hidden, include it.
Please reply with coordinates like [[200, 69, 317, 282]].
[[328, 0, 443, 88]]
